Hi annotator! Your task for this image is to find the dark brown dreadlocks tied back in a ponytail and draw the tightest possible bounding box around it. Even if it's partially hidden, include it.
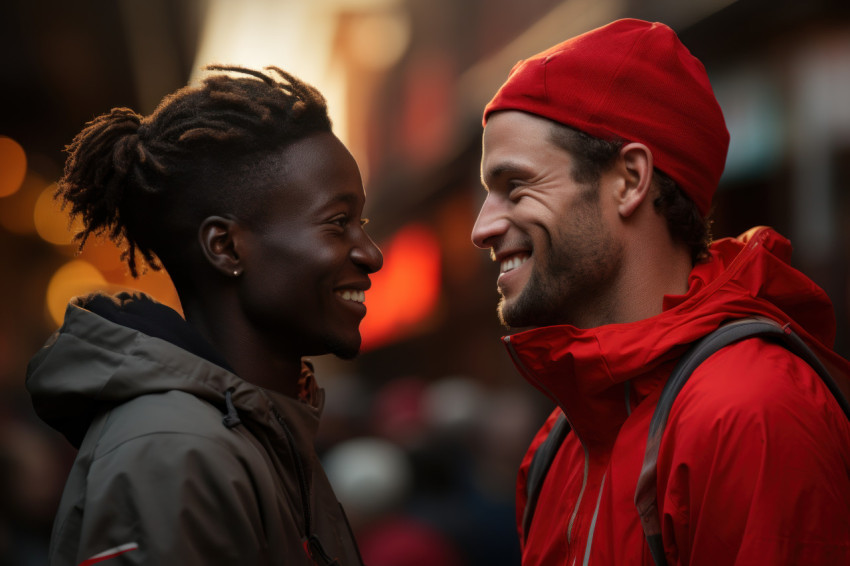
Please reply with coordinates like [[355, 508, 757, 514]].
[[56, 65, 331, 277]]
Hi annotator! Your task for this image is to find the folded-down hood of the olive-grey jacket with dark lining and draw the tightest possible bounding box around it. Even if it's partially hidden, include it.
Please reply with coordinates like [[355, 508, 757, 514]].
[[26, 293, 323, 447]]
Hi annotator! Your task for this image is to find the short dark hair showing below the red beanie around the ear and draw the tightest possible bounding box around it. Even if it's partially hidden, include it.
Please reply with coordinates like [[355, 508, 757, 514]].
[[551, 122, 711, 264]]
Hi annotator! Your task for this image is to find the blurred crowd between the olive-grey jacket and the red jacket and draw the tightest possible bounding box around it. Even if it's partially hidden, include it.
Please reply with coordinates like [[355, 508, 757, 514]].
[[319, 376, 543, 566]]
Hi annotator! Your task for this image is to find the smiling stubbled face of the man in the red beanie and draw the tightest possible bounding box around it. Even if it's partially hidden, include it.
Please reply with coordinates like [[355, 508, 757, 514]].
[[472, 111, 624, 328]]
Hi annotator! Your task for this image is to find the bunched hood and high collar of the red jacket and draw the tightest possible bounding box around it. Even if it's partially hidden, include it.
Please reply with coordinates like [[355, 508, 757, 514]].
[[504, 227, 843, 446]]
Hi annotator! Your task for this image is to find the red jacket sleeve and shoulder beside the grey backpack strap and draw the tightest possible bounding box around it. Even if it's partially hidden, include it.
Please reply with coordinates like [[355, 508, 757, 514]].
[[658, 340, 850, 566]]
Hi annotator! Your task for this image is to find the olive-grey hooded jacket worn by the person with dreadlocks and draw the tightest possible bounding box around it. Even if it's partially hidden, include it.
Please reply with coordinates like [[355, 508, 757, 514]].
[[27, 294, 361, 566]]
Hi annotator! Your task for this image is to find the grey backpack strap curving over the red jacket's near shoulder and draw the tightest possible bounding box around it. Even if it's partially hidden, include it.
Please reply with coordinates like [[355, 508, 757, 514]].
[[635, 318, 850, 566]]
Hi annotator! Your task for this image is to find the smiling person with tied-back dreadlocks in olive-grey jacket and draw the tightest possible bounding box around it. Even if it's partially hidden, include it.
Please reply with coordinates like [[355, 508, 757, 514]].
[[27, 66, 382, 566]]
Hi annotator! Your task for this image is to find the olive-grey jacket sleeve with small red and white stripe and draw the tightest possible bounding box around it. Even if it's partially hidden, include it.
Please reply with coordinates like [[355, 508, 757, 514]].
[[77, 433, 266, 566]]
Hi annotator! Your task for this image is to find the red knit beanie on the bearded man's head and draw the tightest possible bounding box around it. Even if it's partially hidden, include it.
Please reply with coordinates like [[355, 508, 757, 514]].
[[484, 19, 729, 214]]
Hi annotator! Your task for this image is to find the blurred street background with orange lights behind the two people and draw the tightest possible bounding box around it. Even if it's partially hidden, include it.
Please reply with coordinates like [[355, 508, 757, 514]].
[[0, 0, 850, 566]]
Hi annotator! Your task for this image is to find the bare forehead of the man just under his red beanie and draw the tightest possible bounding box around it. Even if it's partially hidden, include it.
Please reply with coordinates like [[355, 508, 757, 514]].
[[481, 110, 569, 181]]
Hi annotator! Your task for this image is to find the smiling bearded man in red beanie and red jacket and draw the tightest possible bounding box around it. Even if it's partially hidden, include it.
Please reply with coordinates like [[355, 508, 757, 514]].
[[472, 20, 850, 566]]
